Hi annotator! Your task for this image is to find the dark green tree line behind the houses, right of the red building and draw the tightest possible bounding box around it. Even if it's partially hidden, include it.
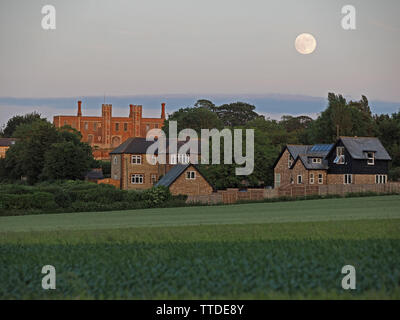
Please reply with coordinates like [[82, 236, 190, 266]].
[[163, 93, 400, 189]]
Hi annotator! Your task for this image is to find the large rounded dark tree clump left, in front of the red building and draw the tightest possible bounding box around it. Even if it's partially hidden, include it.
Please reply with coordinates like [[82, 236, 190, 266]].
[[5, 119, 94, 184]]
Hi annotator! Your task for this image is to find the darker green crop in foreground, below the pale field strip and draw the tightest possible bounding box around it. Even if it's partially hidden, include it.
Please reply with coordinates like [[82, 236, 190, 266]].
[[0, 220, 400, 299]]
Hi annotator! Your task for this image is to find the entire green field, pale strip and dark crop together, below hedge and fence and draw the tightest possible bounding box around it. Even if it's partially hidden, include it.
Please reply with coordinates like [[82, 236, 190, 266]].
[[0, 196, 400, 299]]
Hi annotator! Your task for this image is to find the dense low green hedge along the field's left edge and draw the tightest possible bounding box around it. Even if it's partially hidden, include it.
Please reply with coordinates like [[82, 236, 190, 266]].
[[0, 181, 186, 216]]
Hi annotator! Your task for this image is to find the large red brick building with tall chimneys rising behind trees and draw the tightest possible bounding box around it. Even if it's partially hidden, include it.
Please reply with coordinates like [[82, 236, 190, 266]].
[[53, 101, 165, 160]]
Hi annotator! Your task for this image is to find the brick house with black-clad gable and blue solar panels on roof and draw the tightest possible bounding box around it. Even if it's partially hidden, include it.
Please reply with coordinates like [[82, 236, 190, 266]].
[[274, 137, 391, 188]]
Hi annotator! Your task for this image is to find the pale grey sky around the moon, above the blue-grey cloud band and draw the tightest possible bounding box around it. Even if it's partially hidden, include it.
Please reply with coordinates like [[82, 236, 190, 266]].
[[0, 0, 400, 126]]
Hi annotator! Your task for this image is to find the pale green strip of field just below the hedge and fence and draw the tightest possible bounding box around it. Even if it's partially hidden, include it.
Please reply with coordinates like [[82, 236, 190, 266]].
[[0, 196, 400, 232]]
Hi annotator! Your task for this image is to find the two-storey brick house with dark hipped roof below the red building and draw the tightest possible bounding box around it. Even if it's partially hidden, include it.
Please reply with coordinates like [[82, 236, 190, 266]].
[[110, 138, 200, 190]]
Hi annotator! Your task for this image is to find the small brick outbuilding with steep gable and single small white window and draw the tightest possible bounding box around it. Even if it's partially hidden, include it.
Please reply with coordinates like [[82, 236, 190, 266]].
[[155, 164, 214, 196]]
